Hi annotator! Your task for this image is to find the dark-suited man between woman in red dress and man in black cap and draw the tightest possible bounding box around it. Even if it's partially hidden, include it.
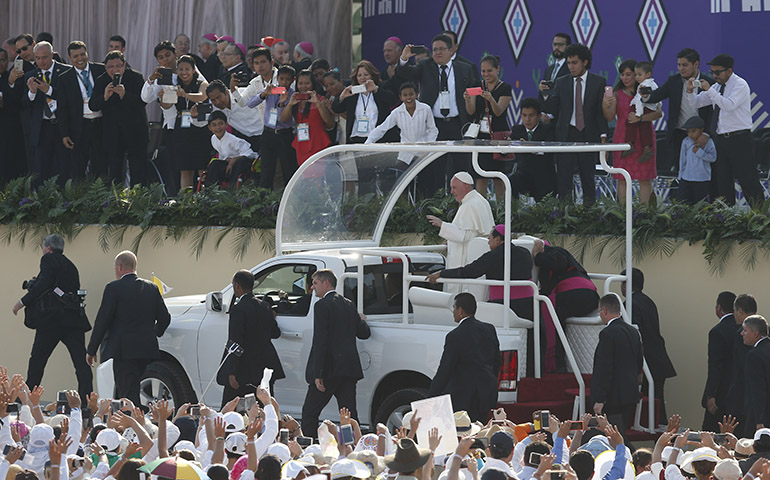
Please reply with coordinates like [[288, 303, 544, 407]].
[[643, 48, 715, 173]]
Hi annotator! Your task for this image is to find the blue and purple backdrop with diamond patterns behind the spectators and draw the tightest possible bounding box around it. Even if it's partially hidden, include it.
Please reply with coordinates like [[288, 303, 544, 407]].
[[362, 0, 770, 130]]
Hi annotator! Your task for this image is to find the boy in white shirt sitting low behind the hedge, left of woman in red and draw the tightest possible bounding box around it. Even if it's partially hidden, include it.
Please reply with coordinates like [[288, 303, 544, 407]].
[[206, 110, 257, 188]]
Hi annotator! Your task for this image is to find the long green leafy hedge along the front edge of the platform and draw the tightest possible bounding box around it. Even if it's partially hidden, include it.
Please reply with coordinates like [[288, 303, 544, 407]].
[[0, 179, 770, 273]]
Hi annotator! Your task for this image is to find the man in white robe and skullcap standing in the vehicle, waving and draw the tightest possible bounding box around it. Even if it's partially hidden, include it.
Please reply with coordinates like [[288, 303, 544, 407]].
[[426, 172, 495, 298]]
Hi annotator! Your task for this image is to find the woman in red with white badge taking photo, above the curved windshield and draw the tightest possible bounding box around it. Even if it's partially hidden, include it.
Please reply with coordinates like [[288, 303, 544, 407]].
[[281, 70, 334, 165]]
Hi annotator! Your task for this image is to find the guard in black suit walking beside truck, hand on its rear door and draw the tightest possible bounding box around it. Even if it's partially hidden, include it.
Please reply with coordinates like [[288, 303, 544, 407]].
[[302, 269, 371, 436]]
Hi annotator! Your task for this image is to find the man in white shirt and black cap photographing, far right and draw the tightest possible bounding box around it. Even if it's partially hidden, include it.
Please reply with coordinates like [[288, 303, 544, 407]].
[[687, 53, 765, 205]]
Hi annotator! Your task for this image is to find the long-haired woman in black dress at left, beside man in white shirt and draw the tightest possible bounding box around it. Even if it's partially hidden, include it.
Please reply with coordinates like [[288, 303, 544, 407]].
[[171, 55, 211, 188]]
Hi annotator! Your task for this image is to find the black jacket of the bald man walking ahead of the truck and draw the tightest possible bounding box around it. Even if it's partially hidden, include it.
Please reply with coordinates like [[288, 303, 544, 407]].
[[87, 273, 171, 361]]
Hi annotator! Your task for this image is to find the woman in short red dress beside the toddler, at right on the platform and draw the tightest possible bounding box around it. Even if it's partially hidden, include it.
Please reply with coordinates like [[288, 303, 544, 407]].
[[602, 59, 663, 204]]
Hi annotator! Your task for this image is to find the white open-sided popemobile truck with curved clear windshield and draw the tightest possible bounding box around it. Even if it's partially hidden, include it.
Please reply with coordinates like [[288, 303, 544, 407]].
[[97, 141, 653, 430]]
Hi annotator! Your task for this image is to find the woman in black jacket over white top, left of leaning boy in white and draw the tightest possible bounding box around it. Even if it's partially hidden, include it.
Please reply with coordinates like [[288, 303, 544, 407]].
[[332, 60, 398, 143]]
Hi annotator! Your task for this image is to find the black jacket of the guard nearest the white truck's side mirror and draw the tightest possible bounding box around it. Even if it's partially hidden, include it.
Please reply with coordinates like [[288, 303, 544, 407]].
[[223, 293, 286, 385]]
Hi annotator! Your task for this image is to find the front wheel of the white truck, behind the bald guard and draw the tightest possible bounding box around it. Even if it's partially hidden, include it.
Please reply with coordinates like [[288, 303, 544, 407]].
[[139, 361, 195, 409]]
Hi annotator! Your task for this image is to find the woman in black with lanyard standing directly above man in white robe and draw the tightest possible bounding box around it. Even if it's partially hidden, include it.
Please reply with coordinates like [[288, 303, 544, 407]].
[[463, 54, 513, 201]]
